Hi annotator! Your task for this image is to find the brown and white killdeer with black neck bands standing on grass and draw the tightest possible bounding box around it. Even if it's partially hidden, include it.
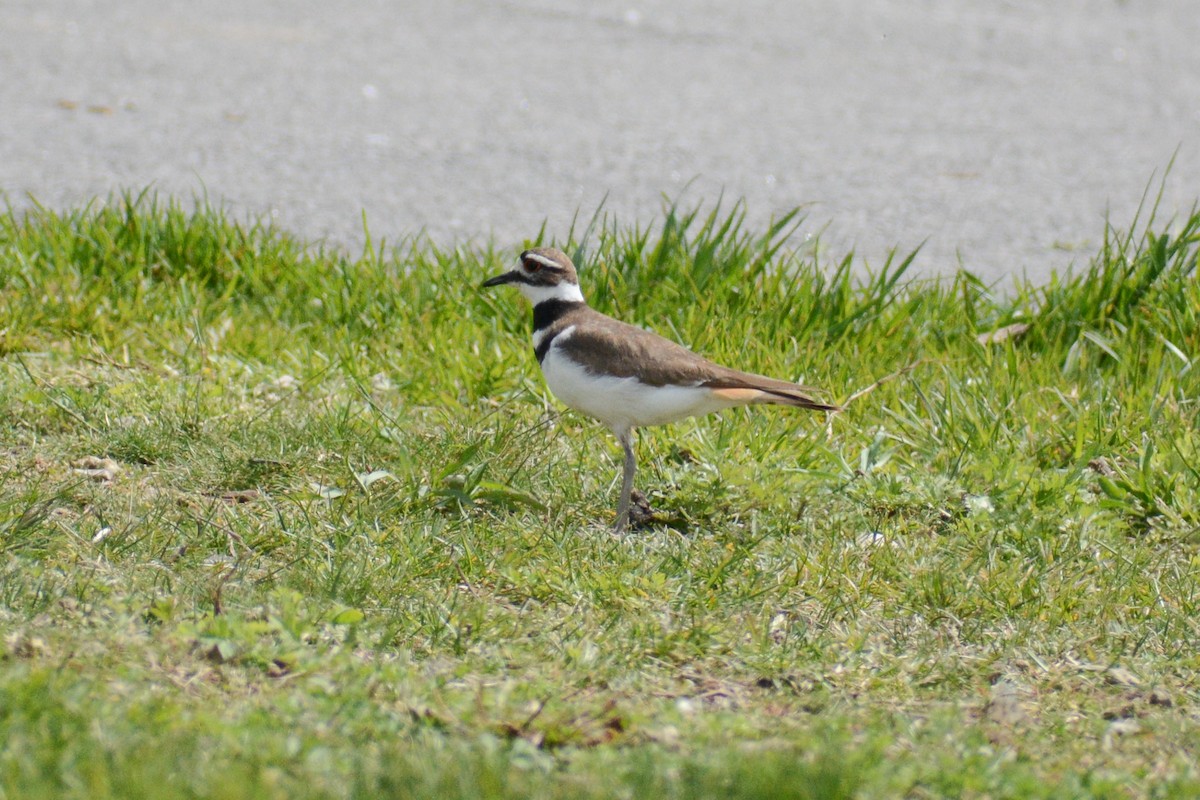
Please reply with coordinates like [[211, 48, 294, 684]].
[[484, 247, 839, 533]]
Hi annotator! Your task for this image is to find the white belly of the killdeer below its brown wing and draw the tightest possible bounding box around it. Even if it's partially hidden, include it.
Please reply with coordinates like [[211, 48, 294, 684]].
[[541, 331, 738, 431]]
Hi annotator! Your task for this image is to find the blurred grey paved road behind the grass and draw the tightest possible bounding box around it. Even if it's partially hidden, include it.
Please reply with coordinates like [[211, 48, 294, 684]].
[[0, 0, 1200, 279]]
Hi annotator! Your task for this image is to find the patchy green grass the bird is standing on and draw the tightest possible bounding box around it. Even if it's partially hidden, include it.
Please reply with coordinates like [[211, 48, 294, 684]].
[[0, 189, 1200, 799]]
